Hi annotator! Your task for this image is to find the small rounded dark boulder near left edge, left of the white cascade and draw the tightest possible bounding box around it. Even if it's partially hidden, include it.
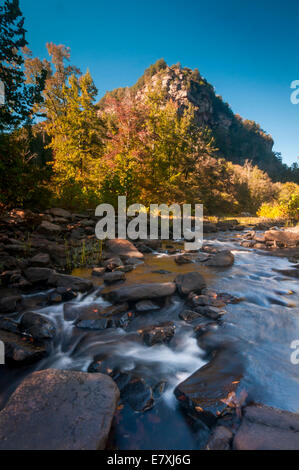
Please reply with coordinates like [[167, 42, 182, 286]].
[[20, 312, 56, 341]]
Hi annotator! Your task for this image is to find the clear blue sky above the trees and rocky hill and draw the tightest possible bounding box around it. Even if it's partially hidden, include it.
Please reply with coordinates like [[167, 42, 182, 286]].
[[20, 0, 299, 164]]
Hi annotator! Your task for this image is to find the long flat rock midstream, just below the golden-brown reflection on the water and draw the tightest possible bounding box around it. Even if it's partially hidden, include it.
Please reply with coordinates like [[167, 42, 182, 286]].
[[104, 282, 176, 303]]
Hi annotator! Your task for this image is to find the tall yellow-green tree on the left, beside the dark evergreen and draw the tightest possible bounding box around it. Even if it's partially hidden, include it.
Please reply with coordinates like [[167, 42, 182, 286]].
[[45, 72, 104, 207]]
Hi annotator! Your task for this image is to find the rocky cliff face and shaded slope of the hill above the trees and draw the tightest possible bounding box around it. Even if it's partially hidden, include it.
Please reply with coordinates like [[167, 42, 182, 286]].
[[99, 62, 282, 178]]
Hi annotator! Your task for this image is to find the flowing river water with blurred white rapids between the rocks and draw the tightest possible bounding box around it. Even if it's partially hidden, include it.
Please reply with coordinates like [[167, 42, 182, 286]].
[[0, 233, 299, 450]]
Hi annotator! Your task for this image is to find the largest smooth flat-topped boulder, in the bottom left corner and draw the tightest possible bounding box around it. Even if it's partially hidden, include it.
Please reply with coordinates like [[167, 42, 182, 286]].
[[0, 369, 119, 450]]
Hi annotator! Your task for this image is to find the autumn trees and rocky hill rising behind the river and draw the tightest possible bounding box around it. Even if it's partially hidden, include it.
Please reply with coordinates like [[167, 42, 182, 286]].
[[0, 0, 299, 218]]
